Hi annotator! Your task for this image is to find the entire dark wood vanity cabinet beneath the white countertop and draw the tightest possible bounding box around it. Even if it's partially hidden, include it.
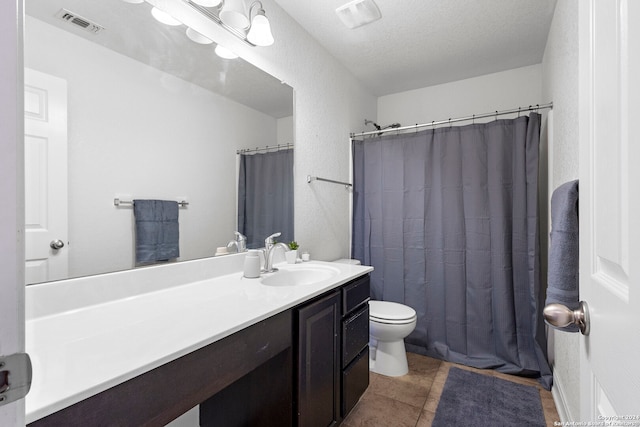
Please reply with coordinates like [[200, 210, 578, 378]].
[[29, 275, 369, 427]]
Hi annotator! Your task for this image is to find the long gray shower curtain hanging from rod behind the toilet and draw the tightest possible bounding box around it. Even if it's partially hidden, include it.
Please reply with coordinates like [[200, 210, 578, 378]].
[[352, 113, 551, 388]]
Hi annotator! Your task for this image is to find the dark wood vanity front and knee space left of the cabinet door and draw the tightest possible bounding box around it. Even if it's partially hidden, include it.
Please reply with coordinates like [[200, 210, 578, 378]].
[[28, 310, 293, 427]]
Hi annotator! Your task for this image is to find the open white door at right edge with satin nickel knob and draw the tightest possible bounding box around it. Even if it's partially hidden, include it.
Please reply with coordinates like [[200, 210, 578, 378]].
[[579, 0, 640, 418]]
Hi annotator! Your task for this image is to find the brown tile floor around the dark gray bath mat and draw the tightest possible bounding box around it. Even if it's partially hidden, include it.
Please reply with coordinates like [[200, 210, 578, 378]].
[[342, 353, 560, 427]]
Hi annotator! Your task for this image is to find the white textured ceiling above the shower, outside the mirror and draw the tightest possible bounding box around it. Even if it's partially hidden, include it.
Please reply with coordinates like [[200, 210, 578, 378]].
[[267, 0, 556, 96]]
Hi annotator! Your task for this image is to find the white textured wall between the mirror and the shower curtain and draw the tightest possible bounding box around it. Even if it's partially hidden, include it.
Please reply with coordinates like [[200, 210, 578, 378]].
[[256, 0, 376, 260]]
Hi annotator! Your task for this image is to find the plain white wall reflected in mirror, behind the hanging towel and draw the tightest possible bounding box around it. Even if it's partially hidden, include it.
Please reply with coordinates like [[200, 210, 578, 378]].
[[25, 17, 278, 277]]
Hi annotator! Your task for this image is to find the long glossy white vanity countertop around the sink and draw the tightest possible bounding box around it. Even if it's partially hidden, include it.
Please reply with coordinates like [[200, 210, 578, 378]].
[[26, 261, 373, 423]]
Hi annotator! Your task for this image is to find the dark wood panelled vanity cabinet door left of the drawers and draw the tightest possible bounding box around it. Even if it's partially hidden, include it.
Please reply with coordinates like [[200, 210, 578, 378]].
[[297, 292, 340, 427]]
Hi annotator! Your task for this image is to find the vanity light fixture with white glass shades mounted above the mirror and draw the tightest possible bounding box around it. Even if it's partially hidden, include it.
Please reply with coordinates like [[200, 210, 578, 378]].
[[183, 0, 274, 46]]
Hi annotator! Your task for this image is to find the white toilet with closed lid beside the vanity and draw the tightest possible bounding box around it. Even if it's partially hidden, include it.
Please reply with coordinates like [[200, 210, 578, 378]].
[[369, 300, 417, 377]]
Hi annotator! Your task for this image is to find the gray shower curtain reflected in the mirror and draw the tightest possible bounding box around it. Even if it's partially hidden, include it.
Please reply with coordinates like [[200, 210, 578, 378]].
[[238, 149, 294, 249]]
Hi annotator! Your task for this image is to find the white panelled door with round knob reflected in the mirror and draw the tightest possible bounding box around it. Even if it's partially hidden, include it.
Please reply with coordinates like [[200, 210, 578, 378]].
[[24, 69, 69, 284]]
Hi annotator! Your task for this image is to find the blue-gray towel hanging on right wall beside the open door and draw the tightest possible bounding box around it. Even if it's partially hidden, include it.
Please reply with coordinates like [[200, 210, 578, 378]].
[[545, 180, 580, 332]]
